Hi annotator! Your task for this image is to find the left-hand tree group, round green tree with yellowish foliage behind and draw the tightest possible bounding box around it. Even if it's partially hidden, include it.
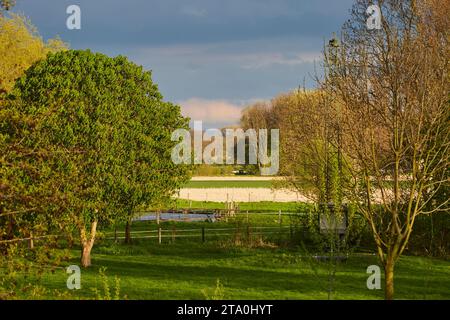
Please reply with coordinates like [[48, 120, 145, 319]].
[[0, 16, 189, 267]]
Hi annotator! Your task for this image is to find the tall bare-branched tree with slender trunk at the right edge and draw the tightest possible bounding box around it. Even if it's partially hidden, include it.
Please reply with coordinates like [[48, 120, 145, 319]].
[[323, 0, 450, 299]]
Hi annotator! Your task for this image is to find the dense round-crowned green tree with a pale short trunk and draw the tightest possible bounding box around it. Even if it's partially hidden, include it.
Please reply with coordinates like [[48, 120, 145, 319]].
[[3, 50, 188, 267]]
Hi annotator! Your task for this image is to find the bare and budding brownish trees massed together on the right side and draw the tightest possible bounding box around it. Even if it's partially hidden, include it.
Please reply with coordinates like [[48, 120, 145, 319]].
[[242, 0, 450, 299]]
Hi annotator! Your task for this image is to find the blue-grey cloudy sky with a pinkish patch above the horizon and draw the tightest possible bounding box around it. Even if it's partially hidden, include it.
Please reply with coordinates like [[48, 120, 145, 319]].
[[9, 0, 353, 128]]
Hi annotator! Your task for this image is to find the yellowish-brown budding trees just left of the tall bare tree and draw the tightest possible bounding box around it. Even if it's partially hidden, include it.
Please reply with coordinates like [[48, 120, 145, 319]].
[[241, 90, 349, 204]]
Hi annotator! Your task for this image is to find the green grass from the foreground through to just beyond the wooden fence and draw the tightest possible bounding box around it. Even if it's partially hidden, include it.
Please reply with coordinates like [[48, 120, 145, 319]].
[[20, 214, 450, 299]]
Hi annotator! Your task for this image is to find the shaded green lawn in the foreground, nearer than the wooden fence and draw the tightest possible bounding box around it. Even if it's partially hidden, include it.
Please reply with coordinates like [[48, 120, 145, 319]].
[[37, 239, 450, 299]]
